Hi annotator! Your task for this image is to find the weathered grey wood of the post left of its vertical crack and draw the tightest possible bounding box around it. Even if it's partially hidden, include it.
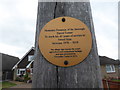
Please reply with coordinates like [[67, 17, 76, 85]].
[[32, 2, 57, 88]]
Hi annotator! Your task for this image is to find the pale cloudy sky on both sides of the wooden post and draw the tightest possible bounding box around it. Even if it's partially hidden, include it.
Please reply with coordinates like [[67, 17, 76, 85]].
[[0, 0, 119, 59]]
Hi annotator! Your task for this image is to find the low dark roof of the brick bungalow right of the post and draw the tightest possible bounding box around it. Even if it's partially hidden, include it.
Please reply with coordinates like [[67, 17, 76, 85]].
[[99, 56, 120, 65]]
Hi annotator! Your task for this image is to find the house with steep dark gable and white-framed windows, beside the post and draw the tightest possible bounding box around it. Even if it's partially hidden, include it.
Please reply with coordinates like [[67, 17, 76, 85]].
[[12, 47, 34, 80]]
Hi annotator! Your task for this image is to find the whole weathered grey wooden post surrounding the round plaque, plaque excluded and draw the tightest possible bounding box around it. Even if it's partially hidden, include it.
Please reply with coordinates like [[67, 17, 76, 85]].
[[32, 2, 102, 88]]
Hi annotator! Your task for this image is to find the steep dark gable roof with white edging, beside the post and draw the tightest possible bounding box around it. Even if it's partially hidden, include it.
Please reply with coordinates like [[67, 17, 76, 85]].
[[13, 47, 34, 69]]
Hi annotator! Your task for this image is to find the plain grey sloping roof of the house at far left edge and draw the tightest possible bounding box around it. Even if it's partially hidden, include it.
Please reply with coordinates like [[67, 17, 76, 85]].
[[0, 53, 20, 71]]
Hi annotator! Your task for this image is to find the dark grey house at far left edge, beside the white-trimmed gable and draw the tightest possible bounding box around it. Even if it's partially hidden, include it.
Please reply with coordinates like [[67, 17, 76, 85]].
[[0, 53, 19, 80]]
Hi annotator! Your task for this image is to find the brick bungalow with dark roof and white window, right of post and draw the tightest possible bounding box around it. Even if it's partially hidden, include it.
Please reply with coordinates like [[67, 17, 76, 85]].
[[99, 56, 120, 78]]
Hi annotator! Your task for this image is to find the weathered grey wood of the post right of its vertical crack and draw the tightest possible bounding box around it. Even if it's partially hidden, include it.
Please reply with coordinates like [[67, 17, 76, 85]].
[[56, 2, 102, 88]]
